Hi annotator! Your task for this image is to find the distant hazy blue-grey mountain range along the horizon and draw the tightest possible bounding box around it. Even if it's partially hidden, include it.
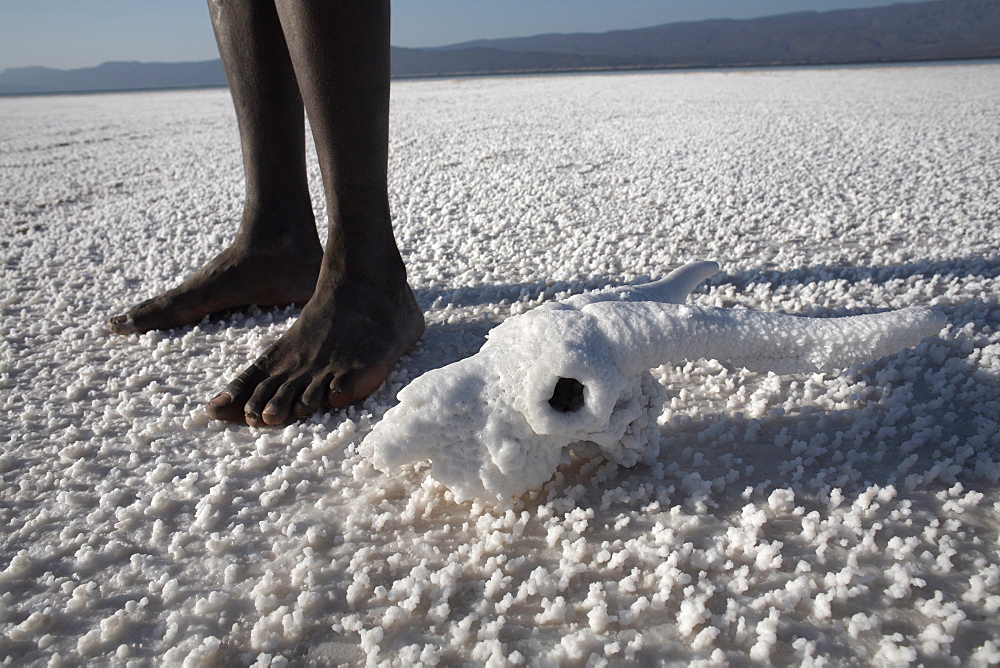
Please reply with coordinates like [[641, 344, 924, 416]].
[[0, 0, 1000, 95]]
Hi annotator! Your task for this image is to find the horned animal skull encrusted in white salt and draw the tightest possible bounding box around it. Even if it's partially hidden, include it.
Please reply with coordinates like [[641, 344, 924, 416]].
[[364, 262, 945, 500]]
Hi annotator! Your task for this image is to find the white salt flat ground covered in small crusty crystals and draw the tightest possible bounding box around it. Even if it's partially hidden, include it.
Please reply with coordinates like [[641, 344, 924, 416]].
[[0, 64, 1000, 666]]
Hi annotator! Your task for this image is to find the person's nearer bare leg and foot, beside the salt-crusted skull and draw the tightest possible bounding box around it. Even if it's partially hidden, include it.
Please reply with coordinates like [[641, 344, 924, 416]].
[[209, 0, 424, 426]]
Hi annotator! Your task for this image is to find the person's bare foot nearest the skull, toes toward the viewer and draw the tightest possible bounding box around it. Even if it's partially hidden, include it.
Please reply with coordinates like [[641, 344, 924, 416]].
[[207, 272, 424, 427]]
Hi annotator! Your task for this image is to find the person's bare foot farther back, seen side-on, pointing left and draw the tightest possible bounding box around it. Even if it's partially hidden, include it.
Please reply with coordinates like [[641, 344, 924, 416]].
[[108, 240, 323, 334]]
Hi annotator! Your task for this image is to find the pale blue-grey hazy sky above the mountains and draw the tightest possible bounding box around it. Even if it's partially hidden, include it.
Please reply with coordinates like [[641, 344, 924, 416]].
[[0, 0, 916, 70]]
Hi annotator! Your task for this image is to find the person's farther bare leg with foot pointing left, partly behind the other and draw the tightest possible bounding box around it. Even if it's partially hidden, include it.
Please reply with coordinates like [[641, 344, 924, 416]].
[[109, 0, 323, 334]]
